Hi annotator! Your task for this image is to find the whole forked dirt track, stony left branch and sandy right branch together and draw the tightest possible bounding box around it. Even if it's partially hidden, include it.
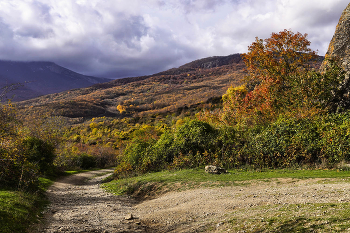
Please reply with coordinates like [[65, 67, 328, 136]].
[[30, 170, 350, 232]]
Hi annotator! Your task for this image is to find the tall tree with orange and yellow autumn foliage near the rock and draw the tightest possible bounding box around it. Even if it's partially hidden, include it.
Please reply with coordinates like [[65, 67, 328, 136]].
[[223, 30, 317, 124]]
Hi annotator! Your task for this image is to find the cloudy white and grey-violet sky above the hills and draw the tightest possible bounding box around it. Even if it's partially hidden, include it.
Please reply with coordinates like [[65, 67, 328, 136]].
[[0, 0, 349, 78]]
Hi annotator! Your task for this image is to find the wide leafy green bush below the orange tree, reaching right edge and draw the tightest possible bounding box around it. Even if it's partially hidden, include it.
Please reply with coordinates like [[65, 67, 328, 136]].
[[242, 113, 350, 168]]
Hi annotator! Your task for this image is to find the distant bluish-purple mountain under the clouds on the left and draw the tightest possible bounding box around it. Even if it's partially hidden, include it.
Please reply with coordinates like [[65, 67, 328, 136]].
[[0, 61, 110, 101]]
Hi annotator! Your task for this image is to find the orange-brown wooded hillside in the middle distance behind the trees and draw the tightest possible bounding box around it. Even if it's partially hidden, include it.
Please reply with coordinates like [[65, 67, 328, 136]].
[[17, 54, 323, 118]]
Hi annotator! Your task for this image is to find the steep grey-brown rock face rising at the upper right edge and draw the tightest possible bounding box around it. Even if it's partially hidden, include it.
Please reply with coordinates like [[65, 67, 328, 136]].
[[320, 3, 350, 73]]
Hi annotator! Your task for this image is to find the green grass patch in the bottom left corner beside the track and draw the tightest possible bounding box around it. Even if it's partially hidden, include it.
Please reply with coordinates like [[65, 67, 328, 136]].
[[0, 190, 47, 233]]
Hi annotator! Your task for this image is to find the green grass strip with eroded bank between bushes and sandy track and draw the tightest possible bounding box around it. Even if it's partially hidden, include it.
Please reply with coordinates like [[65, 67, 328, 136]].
[[103, 169, 350, 198]]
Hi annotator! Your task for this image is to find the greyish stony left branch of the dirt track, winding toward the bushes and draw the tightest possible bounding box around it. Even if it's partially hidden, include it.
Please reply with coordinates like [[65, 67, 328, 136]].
[[33, 169, 147, 233]]
